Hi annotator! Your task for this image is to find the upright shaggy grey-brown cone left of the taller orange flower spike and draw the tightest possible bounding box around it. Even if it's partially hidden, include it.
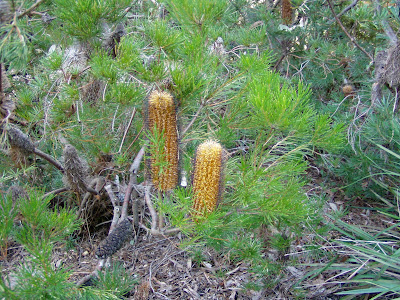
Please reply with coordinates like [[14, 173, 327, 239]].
[[63, 145, 88, 194]]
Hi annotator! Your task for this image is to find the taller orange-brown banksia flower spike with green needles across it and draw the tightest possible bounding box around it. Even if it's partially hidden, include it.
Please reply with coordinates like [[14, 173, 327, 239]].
[[145, 91, 179, 191]]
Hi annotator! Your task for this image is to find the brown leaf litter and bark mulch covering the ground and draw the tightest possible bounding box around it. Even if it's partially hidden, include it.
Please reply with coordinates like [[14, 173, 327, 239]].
[[0, 168, 391, 300]]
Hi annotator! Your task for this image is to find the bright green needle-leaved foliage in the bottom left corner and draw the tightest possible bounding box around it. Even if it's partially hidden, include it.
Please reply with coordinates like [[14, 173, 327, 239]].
[[0, 191, 80, 299]]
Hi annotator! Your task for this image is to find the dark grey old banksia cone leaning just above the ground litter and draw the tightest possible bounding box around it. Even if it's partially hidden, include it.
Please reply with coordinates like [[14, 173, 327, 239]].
[[95, 219, 132, 259]]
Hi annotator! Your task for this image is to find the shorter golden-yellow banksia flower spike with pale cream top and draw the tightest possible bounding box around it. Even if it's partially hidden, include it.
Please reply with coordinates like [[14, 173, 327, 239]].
[[193, 141, 227, 214]]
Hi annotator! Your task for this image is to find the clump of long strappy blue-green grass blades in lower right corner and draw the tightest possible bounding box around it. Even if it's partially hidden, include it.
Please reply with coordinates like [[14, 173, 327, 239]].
[[312, 217, 400, 299]]
